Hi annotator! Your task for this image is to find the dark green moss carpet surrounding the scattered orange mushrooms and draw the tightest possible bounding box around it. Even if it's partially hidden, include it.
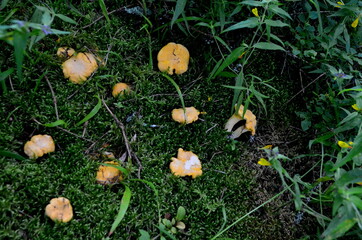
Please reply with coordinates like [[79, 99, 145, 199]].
[[0, 1, 316, 239]]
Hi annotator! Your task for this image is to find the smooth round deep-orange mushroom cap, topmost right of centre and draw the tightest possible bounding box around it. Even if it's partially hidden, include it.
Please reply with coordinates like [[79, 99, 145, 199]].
[[157, 42, 190, 75]]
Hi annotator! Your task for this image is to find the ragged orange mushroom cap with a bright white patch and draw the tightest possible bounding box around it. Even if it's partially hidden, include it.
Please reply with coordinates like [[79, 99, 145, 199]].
[[170, 148, 202, 178]]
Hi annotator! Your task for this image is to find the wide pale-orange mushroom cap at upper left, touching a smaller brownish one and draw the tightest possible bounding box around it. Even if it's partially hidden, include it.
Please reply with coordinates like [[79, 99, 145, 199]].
[[62, 53, 98, 84]]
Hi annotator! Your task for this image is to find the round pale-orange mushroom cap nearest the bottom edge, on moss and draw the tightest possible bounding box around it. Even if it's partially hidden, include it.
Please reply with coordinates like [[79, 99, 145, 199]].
[[45, 197, 73, 222]]
